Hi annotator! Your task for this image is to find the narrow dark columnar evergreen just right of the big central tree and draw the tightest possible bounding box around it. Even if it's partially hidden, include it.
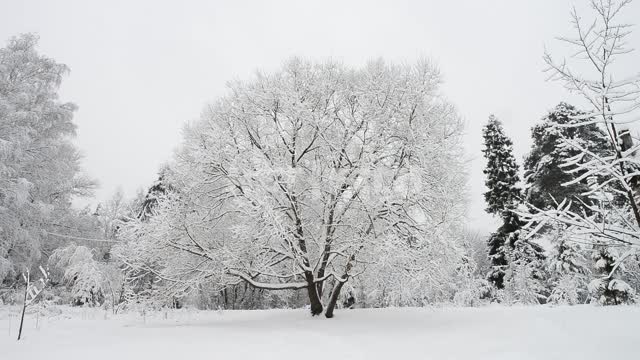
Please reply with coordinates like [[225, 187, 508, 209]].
[[482, 115, 521, 216]]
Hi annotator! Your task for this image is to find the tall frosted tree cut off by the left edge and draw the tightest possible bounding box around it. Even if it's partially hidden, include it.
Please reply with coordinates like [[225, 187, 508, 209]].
[[0, 34, 93, 281]]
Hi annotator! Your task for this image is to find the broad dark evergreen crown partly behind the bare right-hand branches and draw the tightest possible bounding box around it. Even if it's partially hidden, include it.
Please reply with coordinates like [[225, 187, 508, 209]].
[[524, 102, 610, 210]]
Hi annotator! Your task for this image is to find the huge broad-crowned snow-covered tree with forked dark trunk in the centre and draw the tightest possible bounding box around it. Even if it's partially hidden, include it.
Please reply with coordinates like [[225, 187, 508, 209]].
[[120, 59, 465, 317]]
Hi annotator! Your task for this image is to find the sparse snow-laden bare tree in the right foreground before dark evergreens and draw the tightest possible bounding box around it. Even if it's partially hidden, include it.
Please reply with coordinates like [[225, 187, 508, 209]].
[[520, 0, 640, 304]]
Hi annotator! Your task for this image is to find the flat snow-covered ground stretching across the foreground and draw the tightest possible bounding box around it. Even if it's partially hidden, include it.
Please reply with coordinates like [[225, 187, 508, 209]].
[[0, 306, 640, 360]]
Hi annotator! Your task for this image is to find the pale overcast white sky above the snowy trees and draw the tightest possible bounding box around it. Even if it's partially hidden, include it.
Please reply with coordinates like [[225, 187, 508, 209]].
[[0, 0, 640, 231]]
